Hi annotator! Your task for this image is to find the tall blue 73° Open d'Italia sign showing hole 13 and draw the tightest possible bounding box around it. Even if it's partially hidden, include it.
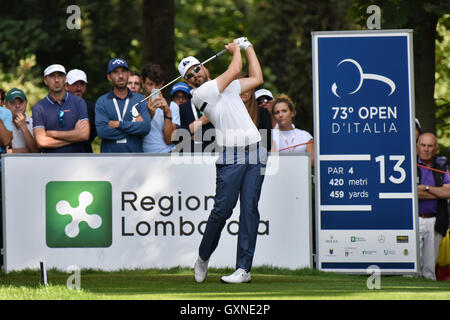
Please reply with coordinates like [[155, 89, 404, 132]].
[[313, 30, 417, 272]]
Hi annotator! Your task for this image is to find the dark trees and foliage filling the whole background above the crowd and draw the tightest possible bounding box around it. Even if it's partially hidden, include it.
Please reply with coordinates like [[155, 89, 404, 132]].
[[0, 0, 450, 145]]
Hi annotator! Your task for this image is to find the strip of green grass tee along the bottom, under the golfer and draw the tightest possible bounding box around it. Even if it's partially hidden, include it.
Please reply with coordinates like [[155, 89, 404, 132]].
[[0, 267, 450, 300]]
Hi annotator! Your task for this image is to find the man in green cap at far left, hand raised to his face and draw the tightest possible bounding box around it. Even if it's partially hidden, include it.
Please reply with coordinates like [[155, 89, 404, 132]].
[[5, 88, 40, 153]]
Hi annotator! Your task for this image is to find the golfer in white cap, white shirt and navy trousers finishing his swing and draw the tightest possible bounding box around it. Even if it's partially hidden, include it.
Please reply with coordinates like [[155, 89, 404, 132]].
[[178, 37, 267, 283]]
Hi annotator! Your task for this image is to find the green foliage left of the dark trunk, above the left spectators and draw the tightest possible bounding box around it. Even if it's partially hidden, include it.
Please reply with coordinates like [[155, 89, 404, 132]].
[[0, 0, 141, 101]]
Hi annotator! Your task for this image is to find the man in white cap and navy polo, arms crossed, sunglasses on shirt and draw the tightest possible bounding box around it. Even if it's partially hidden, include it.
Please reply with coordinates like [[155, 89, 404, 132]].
[[32, 64, 90, 153]]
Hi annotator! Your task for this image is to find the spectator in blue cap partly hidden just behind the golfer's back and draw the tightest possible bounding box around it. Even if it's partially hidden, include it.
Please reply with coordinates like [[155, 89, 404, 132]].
[[171, 82, 214, 152]]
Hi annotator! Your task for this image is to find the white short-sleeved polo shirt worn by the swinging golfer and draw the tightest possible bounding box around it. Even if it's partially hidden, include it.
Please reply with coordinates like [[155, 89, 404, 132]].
[[192, 80, 261, 147]]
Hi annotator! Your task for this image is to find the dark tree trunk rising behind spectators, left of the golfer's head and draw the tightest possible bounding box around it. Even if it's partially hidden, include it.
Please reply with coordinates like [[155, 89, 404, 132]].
[[142, 0, 177, 82]]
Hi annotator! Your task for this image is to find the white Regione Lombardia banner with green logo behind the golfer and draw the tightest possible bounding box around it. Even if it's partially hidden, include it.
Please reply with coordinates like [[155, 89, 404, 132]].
[[3, 154, 312, 272]]
